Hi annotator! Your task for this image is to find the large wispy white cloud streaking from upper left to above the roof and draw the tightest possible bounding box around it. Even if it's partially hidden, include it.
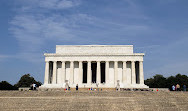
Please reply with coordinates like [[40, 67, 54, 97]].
[[9, 0, 151, 61]]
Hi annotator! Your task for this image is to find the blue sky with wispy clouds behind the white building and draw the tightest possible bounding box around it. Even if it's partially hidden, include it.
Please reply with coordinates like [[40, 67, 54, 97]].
[[0, 0, 188, 84]]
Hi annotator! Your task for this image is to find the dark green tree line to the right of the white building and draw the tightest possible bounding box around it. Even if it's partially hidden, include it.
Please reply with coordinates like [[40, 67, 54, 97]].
[[144, 74, 188, 90]]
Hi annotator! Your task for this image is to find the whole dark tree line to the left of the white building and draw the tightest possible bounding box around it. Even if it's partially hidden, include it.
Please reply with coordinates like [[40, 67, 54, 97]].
[[0, 74, 42, 90]]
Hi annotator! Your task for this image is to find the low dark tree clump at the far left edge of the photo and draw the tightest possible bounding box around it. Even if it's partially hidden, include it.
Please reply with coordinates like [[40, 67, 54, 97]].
[[0, 81, 17, 90]]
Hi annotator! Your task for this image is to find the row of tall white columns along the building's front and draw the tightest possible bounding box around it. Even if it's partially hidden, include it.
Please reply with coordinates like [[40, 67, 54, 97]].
[[44, 61, 144, 84]]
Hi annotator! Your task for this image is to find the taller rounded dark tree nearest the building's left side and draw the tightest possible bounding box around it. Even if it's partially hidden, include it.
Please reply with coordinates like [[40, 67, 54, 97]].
[[15, 74, 42, 87]]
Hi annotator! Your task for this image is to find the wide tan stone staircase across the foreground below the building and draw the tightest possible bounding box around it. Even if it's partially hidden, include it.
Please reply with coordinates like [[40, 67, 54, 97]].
[[0, 90, 188, 111]]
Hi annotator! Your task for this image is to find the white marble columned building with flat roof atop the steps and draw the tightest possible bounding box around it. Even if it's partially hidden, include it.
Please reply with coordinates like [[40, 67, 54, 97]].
[[41, 45, 148, 88]]
